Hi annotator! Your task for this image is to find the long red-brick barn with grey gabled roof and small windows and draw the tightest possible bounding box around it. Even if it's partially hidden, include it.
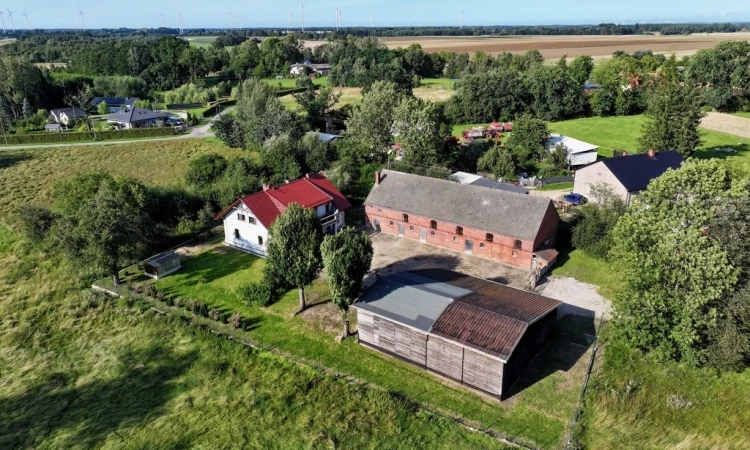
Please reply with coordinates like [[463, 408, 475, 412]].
[[365, 170, 560, 273]]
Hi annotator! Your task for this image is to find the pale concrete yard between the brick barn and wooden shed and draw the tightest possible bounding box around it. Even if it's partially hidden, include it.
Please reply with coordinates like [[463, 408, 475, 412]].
[[365, 233, 530, 289]]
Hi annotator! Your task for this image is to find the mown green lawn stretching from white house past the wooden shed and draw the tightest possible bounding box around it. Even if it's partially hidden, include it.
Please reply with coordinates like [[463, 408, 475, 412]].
[[108, 241, 591, 448]]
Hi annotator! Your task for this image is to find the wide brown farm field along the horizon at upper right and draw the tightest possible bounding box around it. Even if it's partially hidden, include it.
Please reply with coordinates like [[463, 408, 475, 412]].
[[382, 33, 750, 59]]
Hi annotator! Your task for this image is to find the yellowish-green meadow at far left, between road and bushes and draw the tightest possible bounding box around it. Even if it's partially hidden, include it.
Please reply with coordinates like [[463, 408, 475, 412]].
[[0, 139, 245, 222]]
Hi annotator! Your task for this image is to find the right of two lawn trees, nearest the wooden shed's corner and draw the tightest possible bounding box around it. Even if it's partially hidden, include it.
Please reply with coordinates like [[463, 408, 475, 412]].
[[320, 227, 373, 336]]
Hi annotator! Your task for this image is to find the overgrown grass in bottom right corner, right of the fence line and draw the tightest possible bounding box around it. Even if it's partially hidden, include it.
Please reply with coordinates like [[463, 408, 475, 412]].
[[581, 336, 750, 450]]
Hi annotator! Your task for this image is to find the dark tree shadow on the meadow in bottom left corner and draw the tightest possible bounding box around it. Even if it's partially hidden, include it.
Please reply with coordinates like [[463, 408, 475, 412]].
[[0, 345, 198, 448]]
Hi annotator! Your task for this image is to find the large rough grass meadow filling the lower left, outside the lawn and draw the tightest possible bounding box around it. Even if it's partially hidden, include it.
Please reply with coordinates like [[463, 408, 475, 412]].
[[0, 225, 506, 449]]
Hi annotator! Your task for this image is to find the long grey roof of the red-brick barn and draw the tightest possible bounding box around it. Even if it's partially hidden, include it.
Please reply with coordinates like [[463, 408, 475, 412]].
[[365, 170, 551, 241]]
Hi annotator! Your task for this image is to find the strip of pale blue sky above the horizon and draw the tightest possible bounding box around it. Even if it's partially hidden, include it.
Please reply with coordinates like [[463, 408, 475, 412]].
[[5, 0, 750, 28]]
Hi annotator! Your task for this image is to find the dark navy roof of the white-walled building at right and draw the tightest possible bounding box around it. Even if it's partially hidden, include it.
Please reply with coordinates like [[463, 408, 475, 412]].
[[600, 150, 684, 192]]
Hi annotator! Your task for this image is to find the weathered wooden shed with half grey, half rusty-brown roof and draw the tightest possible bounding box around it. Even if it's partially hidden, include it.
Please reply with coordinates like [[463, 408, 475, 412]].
[[352, 269, 561, 398]]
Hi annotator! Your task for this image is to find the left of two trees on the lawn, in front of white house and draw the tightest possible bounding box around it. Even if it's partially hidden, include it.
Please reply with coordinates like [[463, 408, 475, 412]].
[[264, 203, 323, 310]]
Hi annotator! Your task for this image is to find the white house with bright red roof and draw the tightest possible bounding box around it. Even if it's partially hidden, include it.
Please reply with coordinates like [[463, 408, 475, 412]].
[[215, 174, 352, 256]]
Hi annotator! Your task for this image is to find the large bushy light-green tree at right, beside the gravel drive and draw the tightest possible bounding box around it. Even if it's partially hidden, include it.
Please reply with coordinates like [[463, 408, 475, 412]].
[[612, 160, 744, 366]]
